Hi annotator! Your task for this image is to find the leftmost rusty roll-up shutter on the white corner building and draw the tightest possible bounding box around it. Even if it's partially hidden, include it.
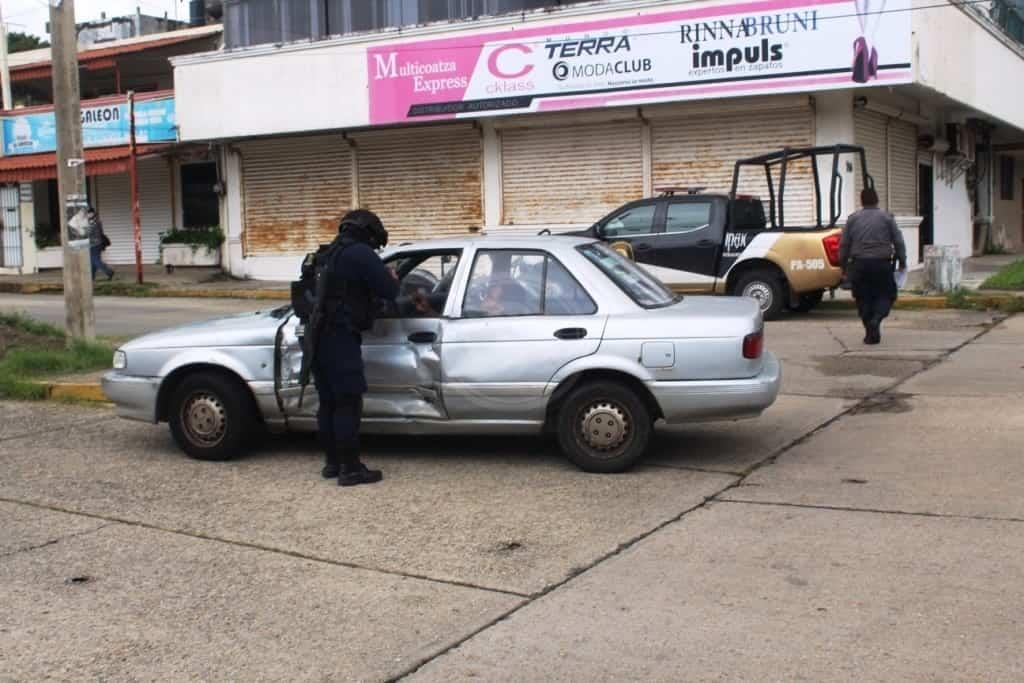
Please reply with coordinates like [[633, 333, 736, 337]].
[[239, 135, 352, 256]]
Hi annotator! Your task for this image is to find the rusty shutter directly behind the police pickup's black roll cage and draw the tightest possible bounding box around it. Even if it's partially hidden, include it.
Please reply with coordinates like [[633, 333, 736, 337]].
[[651, 104, 815, 226]]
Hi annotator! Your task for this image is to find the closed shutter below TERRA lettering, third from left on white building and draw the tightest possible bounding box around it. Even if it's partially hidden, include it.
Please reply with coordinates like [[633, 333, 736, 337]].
[[500, 121, 643, 225]]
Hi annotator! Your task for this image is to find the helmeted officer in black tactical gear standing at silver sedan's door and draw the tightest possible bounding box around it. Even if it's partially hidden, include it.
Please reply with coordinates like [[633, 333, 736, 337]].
[[312, 209, 398, 486]]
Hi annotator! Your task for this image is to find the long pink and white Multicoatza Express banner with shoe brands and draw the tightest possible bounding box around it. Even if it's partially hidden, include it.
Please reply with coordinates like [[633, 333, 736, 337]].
[[367, 0, 913, 124]]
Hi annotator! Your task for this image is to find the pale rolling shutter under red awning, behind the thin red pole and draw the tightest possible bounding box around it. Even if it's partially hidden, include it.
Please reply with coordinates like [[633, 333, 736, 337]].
[[95, 157, 174, 265]]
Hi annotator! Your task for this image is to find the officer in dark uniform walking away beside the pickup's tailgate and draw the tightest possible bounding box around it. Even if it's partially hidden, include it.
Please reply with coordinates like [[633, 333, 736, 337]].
[[839, 187, 906, 344]]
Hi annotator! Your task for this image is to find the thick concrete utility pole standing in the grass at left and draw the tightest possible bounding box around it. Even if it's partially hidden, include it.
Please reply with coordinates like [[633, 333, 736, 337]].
[[50, 0, 96, 340]]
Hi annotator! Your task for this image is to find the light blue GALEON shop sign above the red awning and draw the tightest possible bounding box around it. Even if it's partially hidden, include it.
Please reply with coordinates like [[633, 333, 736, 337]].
[[3, 97, 178, 156]]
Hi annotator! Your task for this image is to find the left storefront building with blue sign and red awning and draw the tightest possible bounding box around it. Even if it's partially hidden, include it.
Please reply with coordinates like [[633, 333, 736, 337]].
[[0, 27, 220, 274]]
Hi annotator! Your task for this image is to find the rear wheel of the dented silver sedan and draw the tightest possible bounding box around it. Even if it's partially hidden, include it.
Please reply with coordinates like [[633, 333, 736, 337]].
[[558, 382, 653, 474]]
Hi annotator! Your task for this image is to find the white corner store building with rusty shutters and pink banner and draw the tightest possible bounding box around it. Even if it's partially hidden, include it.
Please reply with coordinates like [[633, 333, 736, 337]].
[[173, 0, 1024, 279]]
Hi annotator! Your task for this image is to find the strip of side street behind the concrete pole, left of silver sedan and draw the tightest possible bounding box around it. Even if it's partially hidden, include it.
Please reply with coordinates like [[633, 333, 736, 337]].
[[0, 294, 272, 337]]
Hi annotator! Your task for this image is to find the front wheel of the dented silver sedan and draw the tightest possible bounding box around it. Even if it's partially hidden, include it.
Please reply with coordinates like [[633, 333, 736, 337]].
[[168, 373, 257, 461]]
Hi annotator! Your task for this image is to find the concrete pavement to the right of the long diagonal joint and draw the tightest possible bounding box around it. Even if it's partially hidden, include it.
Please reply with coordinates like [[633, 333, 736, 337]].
[[411, 317, 1024, 681]]
